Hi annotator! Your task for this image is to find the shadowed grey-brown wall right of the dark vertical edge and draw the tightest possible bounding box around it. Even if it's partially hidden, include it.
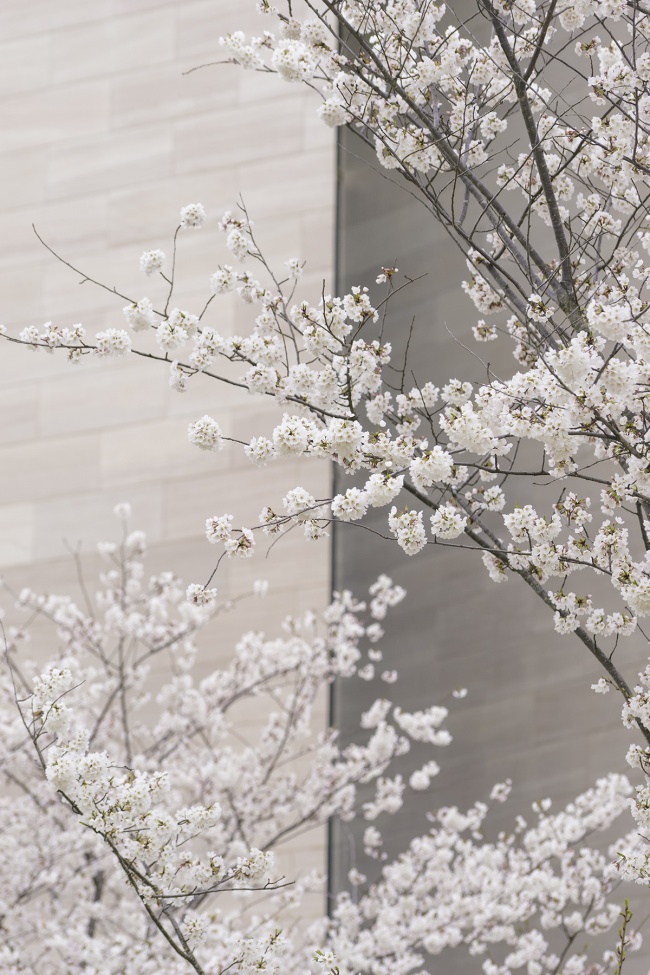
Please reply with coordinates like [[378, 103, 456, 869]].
[[331, 131, 644, 890]]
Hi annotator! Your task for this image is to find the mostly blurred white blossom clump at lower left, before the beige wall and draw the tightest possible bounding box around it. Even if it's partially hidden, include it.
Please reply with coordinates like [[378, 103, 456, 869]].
[[0, 505, 458, 975]]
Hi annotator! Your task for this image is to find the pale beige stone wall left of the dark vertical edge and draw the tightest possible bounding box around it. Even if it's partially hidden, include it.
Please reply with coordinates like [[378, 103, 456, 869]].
[[0, 0, 334, 904]]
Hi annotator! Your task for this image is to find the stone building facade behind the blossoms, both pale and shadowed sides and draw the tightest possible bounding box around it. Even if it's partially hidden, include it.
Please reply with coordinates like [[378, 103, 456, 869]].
[[0, 0, 635, 952]]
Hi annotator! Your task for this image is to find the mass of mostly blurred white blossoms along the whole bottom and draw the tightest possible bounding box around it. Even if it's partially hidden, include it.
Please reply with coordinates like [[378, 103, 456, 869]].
[[0, 506, 645, 975]]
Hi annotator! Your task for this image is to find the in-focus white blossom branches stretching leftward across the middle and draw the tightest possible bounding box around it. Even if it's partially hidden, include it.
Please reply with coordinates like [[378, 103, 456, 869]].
[[7, 189, 650, 692]]
